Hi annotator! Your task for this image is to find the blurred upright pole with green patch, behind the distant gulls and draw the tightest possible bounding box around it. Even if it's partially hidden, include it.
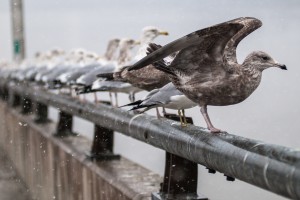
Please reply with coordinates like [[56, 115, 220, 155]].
[[10, 0, 25, 62]]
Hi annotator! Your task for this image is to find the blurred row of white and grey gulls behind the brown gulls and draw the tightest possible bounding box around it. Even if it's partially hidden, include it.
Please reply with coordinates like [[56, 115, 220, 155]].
[[0, 26, 168, 101]]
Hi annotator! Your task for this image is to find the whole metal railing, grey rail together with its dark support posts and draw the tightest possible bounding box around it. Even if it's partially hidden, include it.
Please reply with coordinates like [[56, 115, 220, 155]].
[[0, 80, 300, 199]]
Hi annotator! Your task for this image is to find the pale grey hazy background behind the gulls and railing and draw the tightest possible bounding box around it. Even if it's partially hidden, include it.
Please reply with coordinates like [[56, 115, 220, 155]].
[[0, 0, 300, 200]]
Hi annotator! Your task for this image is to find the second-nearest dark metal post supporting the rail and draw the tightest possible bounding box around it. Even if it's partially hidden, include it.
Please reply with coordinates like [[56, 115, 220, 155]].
[[87, 102, 120, 161]]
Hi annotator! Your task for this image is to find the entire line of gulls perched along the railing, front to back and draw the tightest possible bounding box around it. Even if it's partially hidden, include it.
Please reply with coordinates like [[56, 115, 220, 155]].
[[0, 17, 287, 133]]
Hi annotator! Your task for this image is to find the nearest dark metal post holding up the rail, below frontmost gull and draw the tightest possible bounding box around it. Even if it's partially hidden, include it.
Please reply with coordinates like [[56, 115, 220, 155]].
[[152, 114, 207, 200]]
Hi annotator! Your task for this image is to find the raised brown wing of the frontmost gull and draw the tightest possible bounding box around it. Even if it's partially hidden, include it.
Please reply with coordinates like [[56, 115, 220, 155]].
[[129, 17, 262, 71]]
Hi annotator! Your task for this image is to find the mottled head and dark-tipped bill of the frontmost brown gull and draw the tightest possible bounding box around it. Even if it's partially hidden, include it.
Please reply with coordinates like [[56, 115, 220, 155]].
[[243, 51, 287, 71]]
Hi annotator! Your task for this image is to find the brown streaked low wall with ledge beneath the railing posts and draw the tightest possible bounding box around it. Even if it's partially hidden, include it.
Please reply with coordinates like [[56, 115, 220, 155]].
[[0, 102, 161, 200]]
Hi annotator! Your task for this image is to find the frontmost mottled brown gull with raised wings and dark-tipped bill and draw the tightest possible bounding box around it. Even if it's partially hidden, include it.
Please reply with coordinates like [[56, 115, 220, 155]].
[[128, 17, 287, 133]]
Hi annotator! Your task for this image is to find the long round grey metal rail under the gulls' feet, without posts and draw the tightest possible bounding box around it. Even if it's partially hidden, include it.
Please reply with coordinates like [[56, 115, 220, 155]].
[[1, 82, 300, 199]]
